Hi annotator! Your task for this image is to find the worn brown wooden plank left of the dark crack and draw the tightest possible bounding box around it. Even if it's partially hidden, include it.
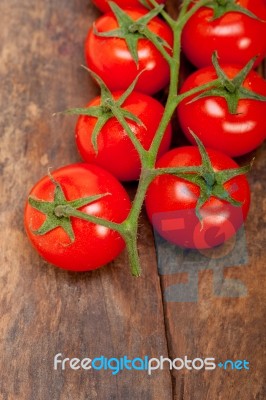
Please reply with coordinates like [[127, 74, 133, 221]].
[[0, 0, 172, 400]]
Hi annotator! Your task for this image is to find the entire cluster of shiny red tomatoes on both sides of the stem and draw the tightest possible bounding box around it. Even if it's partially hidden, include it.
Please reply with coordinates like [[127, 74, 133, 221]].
[[25, 0, 266, 271]]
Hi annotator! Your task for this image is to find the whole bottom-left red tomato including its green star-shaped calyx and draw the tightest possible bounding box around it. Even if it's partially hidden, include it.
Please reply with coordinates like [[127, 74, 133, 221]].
[[24, 163, 131, 272]]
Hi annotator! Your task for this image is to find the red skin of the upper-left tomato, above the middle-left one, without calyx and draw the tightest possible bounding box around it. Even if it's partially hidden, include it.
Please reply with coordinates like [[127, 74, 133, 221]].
[[85, 8, 173, 94]]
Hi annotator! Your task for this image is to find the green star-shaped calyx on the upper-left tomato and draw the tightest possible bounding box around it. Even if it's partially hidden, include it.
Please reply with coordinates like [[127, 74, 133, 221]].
[[93, 1, 170, 65]]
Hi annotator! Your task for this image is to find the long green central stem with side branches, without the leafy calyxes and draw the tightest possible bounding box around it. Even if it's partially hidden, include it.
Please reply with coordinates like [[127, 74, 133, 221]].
[[70, 0, 217, 276]]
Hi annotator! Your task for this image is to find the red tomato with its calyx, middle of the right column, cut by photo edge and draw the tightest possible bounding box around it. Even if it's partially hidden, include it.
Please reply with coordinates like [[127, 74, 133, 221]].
[[177, 63, 266, 157]]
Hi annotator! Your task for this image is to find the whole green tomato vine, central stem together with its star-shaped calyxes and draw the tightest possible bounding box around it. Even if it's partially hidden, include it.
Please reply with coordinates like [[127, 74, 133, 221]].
[[29, 0, 266, 276]]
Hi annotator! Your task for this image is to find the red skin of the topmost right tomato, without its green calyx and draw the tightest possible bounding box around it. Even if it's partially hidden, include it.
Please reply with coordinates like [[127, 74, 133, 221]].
[[182, 0, 266, 68]]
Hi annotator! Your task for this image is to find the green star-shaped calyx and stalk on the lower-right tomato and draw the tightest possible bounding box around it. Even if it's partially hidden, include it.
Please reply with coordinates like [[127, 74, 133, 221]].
[[152, 134, 252, 221]]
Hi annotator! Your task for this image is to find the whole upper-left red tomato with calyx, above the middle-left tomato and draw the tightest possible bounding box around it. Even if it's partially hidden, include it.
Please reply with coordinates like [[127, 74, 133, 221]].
[[85, 4, 173, 94]]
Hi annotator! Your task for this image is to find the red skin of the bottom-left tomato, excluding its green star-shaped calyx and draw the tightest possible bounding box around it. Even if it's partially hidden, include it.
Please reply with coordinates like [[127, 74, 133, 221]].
[[24, 163, 131, 272]]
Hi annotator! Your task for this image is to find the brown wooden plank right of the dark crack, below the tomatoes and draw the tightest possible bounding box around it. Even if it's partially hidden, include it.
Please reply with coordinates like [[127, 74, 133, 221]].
[[158, 2, 266, 394]]
